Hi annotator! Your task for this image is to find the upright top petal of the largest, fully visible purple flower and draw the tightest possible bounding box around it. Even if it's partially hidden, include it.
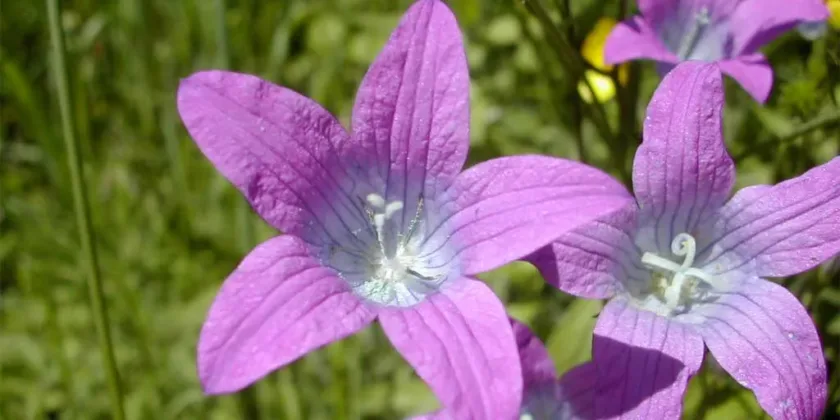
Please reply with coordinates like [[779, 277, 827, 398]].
[[352, 0, 469, 202]]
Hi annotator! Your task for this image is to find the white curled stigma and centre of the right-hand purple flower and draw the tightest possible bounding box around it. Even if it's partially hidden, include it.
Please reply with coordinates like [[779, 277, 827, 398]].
[[642, 233, 719, 315]]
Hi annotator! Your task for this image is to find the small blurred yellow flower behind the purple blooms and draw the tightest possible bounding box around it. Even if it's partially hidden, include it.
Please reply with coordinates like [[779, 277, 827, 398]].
[[578, 17, 628, 103]]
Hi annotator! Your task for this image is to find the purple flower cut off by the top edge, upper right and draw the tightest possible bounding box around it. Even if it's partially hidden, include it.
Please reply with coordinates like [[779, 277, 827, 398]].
[[604, 0, 828, 102]]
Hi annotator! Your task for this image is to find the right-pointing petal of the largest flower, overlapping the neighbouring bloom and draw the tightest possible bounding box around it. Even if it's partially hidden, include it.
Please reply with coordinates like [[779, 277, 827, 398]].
[[436, 156, 632, 274]]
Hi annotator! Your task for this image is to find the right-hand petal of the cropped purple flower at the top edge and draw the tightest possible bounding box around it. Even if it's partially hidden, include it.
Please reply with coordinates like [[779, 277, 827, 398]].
[[730, 0, 829, 56]]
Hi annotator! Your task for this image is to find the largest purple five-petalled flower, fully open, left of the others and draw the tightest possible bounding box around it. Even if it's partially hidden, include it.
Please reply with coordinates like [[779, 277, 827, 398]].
[[178, 0, 627, 419]]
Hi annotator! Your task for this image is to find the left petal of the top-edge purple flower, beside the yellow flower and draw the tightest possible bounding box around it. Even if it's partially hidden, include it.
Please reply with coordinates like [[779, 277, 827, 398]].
[[604, 16, 679, 64]]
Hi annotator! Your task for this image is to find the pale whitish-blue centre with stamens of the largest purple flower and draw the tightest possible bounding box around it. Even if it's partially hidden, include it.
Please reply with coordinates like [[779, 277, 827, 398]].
[[329, 194, 450, 307]]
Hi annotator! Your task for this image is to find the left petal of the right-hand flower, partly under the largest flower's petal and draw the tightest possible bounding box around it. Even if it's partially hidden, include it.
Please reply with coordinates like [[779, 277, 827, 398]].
[[526, 202, 650, 299]]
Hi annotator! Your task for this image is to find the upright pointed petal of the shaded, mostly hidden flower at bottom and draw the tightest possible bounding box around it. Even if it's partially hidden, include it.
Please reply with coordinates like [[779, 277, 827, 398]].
[[510, 318, 557, 388]]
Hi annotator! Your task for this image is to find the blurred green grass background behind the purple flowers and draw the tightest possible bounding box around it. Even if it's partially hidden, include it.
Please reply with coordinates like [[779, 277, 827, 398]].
[[0, 0, 840, 420]]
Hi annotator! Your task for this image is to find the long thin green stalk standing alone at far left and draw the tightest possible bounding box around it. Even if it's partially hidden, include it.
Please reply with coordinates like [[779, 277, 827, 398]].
[[46, 0, 125, 420]]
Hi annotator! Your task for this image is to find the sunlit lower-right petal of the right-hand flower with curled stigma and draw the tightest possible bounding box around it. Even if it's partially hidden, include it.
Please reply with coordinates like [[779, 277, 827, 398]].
[[699, 278, 827, 419]]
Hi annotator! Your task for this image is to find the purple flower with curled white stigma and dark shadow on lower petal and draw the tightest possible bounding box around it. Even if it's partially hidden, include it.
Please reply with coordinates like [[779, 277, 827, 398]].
[[529, 62, 840, 419]]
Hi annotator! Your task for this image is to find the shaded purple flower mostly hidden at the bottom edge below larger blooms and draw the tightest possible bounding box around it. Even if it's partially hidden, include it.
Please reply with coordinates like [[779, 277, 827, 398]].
[[412, 319, 595, 420]]
